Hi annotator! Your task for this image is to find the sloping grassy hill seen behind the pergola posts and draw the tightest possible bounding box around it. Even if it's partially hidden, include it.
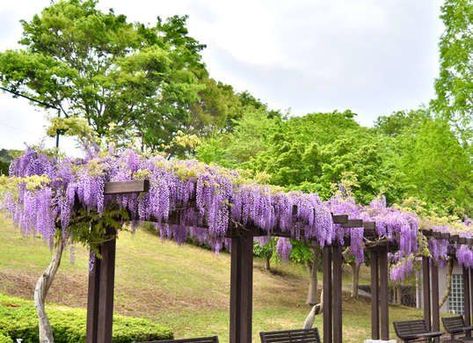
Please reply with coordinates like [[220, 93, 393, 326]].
[[0, 217, 420, 343]]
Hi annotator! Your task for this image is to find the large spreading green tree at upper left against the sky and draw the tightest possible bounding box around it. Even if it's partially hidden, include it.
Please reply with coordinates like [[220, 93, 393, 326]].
[[0, 0, 206, 150]]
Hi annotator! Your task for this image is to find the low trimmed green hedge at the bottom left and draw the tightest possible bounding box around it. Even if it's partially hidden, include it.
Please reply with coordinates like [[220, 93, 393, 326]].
[[0, 295, 173, 343]]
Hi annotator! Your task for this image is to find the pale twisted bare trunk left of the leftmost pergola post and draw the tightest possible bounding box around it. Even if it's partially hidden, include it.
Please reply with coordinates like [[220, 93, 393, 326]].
[[34, 237, 66, 343]]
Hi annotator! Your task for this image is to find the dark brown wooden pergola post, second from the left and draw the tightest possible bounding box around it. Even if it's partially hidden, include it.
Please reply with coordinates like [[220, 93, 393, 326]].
[[230, 230, 253, 343]]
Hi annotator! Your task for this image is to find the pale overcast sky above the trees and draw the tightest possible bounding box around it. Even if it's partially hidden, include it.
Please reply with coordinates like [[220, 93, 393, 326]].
[[0, 0, 442, 149]]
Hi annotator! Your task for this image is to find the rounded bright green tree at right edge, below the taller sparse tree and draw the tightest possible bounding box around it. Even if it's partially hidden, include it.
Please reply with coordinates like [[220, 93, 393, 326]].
[[398, 119, 473, 215]]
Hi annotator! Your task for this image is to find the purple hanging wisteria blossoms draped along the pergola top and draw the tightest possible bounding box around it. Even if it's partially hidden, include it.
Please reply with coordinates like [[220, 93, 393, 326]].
[[2, 149, 473, 281]]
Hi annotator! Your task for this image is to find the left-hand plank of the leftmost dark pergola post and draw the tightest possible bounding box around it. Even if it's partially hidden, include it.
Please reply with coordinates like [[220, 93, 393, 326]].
[[86, 252, 101, 343]]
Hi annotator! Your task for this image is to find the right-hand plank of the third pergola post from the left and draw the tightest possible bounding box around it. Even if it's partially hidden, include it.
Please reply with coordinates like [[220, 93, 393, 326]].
[[332, 245, 343, 343]]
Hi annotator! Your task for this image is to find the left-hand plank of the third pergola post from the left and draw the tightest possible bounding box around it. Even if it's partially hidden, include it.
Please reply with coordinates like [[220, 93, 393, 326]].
[[322, 246, 332, 343]]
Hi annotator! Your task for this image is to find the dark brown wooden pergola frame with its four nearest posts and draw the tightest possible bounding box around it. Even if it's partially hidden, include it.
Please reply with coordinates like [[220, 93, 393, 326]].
[[87, 180, 394, 343]]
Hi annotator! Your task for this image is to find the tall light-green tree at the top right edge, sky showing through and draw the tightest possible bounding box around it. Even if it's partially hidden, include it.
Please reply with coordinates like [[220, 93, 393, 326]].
[[432, 0, 473, 146]]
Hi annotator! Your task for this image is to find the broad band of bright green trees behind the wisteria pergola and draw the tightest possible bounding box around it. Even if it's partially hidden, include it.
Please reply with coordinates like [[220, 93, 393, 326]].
[[197, 110, 473, 218]]
